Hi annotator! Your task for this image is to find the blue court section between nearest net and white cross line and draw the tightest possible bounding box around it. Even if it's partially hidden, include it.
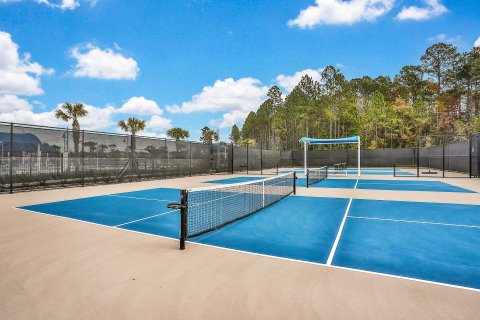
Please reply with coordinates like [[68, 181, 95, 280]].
[[193, 197, 348, 263]]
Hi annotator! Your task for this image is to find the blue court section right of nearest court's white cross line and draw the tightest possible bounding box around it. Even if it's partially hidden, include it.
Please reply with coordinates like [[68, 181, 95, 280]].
[[333, 200, 480, 288]]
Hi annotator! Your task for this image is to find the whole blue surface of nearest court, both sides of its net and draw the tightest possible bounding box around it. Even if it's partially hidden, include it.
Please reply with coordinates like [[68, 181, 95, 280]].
[[16, 188, 480, 289]]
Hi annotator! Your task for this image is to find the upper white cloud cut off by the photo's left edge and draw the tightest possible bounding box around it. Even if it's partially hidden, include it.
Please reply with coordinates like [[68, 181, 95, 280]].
[[0, 31, 53, 95]]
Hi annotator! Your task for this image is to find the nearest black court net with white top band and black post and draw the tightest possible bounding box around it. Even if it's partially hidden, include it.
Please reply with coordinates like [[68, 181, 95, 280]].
[[180, 172, 296, 249]]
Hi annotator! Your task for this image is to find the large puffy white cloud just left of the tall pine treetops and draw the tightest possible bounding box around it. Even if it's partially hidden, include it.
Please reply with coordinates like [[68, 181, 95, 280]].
[[166, 78, 268, 127]]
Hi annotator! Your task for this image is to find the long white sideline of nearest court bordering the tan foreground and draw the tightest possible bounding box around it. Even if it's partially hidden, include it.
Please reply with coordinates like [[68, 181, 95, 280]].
[[13, 207, 480, 292]]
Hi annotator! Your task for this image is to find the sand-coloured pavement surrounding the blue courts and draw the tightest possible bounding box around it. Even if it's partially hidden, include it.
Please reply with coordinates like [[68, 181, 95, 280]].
[[0, 170, 480, 319]]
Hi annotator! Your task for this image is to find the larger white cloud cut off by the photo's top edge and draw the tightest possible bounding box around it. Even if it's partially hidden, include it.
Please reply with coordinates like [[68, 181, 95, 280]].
[[288, 0, 395, 29]]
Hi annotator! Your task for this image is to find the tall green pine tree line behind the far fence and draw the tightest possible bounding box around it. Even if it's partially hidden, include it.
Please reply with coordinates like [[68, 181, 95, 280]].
[[230, 43, 480, 150]]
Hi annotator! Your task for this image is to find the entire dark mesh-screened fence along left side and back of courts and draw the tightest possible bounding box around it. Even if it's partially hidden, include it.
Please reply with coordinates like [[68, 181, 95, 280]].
[[0, 122, 480, 193]]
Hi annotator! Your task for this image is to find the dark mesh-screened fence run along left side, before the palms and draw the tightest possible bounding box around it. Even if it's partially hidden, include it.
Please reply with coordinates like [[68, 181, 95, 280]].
[[0, 122, 280, 193]]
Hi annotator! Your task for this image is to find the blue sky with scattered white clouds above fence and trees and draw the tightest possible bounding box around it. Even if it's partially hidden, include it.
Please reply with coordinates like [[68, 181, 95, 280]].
[[0, 0, 480, 140]]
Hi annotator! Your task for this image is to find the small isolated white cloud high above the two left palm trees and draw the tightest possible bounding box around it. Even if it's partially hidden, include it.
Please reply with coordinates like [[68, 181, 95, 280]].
[[71, 44, 139, 80]]
